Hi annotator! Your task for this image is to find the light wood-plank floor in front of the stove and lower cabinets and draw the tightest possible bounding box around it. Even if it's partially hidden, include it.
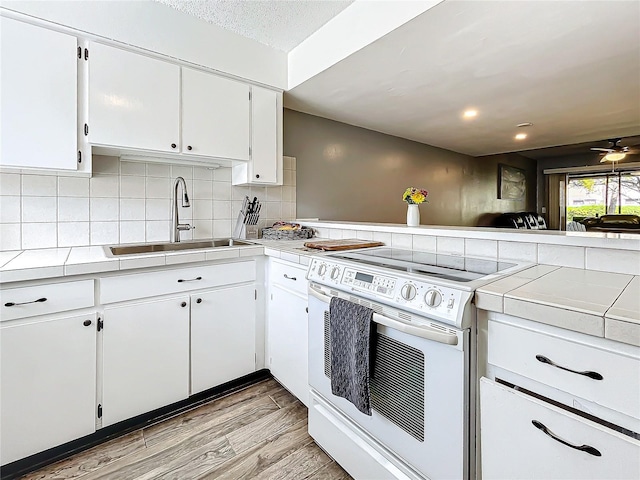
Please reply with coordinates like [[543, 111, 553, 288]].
[[22, 379, 351, 480]]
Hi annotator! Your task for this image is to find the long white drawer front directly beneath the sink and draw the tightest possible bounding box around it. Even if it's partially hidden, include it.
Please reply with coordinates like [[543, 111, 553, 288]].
[[100, 260, 256, 304]]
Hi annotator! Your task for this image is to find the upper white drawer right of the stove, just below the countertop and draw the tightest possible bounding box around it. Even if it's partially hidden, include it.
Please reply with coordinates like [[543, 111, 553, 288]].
[[488, 321, 640, 419]]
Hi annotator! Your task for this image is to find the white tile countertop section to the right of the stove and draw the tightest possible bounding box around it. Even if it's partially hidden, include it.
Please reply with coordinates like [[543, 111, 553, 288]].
[[475, 265, 640, 346]]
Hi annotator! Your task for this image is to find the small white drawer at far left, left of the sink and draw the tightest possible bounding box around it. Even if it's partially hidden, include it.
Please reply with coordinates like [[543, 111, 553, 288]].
[[0, 280, 95, 321]]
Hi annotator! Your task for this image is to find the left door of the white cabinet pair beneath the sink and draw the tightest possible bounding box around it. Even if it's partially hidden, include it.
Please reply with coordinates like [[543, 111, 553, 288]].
[[102, 296, 189, 426]]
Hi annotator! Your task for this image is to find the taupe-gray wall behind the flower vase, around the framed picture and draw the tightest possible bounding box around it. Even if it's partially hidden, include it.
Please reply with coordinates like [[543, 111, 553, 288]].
[[284, 109, 536, 226]]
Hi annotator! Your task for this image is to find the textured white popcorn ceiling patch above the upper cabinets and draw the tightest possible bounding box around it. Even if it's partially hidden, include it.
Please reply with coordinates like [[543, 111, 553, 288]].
[[156, 0, 353, 52]]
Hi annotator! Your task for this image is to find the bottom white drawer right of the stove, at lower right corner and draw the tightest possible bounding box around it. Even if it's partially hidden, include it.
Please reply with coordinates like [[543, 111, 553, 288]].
[[480, 378, 640, 480]]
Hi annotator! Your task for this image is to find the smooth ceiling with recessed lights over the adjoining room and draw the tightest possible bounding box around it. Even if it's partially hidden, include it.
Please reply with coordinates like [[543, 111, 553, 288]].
[[285, 0, 640, 156]]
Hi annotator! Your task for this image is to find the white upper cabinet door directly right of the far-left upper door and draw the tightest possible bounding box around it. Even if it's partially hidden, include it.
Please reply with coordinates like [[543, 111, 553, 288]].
[[89, 43, 180, 152]]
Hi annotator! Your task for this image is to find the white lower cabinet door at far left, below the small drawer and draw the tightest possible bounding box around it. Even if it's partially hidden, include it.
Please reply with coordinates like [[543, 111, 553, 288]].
[[0, 314, 96, 465]]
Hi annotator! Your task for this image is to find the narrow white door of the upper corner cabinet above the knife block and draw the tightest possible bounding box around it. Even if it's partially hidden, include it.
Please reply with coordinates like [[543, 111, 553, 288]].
[[251, 87, 278, 183]]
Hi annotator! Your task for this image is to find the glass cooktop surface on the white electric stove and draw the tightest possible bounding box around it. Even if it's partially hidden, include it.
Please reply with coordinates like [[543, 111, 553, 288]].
[[331, 247, 516, 282]]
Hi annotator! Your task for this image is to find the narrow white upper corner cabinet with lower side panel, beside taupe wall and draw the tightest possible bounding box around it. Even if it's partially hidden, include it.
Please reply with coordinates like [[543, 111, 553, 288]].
[[232, 86, 282, 185]]
